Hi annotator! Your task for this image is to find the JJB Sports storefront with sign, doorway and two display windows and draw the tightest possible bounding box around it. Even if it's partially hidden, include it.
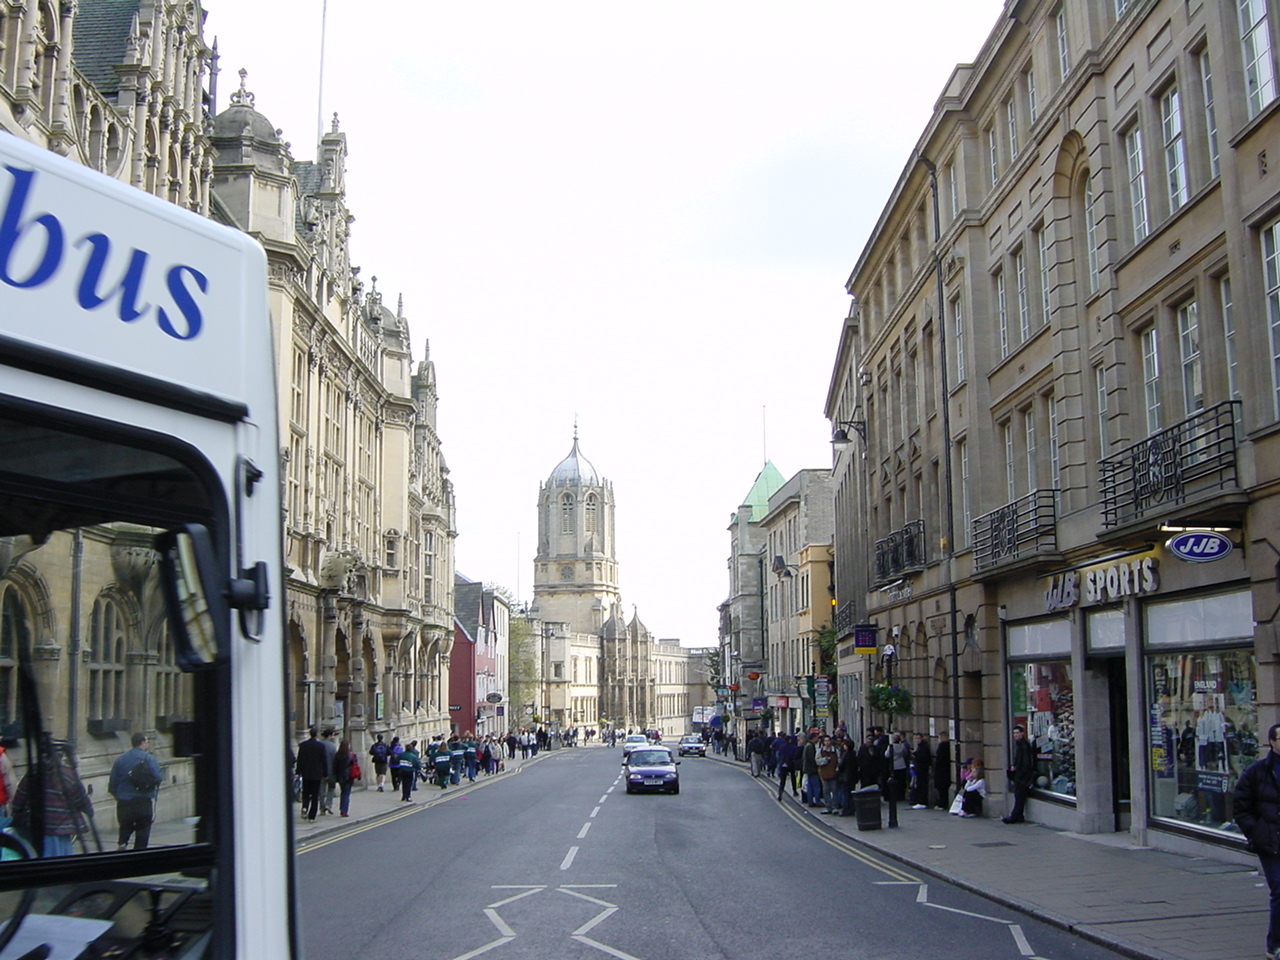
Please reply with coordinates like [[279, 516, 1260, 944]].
[[1001, 534, 1254, 851]]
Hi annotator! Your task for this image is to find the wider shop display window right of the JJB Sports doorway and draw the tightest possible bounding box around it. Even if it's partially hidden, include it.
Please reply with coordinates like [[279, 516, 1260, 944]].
[[1147, 648, 1266, 832]]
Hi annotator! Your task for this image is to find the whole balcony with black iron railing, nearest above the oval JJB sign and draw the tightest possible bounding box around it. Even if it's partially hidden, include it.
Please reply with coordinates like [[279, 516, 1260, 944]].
[[1098, 401, 1248, 539]]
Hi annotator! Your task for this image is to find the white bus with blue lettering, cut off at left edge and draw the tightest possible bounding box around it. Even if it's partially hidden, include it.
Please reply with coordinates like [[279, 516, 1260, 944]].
[[0, 133, 297, 960]]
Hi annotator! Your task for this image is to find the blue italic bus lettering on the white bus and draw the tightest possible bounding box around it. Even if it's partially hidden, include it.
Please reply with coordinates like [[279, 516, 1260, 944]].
[[0, 166, 209, 340]]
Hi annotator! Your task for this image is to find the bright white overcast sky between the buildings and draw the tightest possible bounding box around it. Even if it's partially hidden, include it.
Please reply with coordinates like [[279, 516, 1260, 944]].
[[205, 0, 1004, 645]]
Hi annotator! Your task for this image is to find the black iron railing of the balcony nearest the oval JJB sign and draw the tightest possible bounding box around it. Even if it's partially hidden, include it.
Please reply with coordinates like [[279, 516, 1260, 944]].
[[1098, 401, 1240, 527]]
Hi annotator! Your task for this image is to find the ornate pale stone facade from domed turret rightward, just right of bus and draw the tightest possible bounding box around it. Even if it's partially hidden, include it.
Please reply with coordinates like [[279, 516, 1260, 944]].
[[211, 79, 460, 746]]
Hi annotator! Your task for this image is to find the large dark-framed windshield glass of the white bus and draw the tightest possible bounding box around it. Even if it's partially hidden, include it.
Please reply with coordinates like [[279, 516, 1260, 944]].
[[0, 407, 218, 956]]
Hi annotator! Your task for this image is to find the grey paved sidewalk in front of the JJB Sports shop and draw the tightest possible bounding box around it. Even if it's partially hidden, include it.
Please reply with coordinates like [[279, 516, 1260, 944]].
[[707, 753, 1268, 960]]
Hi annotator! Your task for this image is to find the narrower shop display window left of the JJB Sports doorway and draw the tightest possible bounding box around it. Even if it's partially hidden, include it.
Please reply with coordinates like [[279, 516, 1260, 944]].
[[1009, 660, 1075, 796]]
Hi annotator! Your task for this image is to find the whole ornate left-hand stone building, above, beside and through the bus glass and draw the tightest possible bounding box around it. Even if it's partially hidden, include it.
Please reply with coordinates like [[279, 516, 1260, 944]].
[[0, 0, 454, 778]]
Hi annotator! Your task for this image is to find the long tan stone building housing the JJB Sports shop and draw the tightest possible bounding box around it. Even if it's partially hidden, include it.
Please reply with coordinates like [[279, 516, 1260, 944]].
[[827, 0, 1280, 854]]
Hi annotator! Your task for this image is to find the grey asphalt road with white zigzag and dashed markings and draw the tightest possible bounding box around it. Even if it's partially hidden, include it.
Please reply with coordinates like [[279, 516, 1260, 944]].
[[298, 748, 1119, 960]]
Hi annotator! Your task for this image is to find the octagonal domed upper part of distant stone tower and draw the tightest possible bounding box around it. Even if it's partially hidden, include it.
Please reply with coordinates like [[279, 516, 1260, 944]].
[[531, 429, 622, 635]]
